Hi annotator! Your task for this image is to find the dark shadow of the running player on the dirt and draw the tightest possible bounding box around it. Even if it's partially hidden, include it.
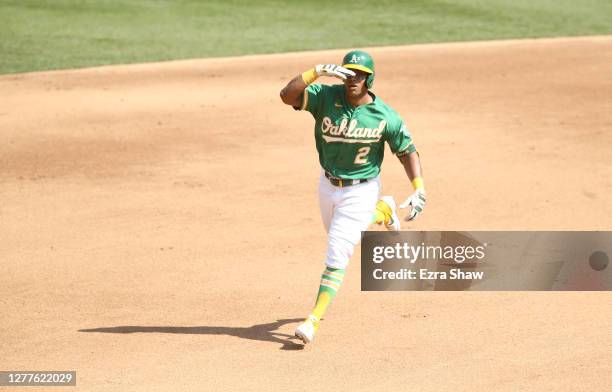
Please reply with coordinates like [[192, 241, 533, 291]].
[[79, 318, 304, 350]]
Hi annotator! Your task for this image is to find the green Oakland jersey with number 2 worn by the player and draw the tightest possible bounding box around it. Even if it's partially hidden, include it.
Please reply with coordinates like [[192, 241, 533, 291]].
[[300, 84, 416, 179]]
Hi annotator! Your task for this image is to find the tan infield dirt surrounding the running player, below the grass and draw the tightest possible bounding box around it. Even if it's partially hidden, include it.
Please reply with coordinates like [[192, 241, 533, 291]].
[[0, 37, 612, 392]]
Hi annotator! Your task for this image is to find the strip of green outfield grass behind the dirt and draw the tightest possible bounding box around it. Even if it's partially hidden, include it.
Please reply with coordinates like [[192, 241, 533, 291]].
[[0, 0, 612, 73]]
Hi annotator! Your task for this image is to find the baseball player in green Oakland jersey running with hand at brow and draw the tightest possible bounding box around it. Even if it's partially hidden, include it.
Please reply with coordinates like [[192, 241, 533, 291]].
[[280, 50, 425, 343]]
